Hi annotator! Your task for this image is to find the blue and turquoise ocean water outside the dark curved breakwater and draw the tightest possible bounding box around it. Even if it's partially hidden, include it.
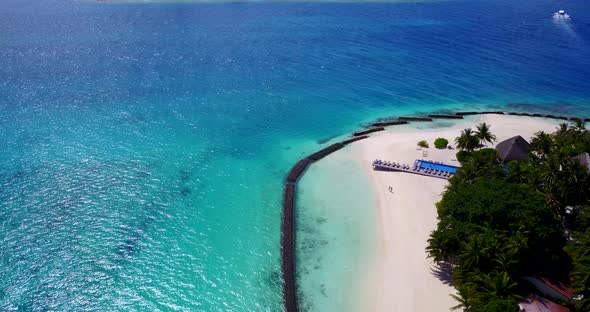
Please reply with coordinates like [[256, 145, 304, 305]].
[[0, 0, 590, 311]]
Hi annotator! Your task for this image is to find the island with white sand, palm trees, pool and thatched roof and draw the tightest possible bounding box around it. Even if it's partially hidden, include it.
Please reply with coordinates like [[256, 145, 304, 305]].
[[292, 113, 590, 312]]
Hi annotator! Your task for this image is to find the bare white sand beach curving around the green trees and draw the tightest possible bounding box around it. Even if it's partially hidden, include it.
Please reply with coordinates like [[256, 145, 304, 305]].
[[355, 115, 564, 312]]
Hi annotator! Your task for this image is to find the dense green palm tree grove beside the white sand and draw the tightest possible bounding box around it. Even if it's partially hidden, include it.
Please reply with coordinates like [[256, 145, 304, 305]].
[[427, 122, 590, 312]]
